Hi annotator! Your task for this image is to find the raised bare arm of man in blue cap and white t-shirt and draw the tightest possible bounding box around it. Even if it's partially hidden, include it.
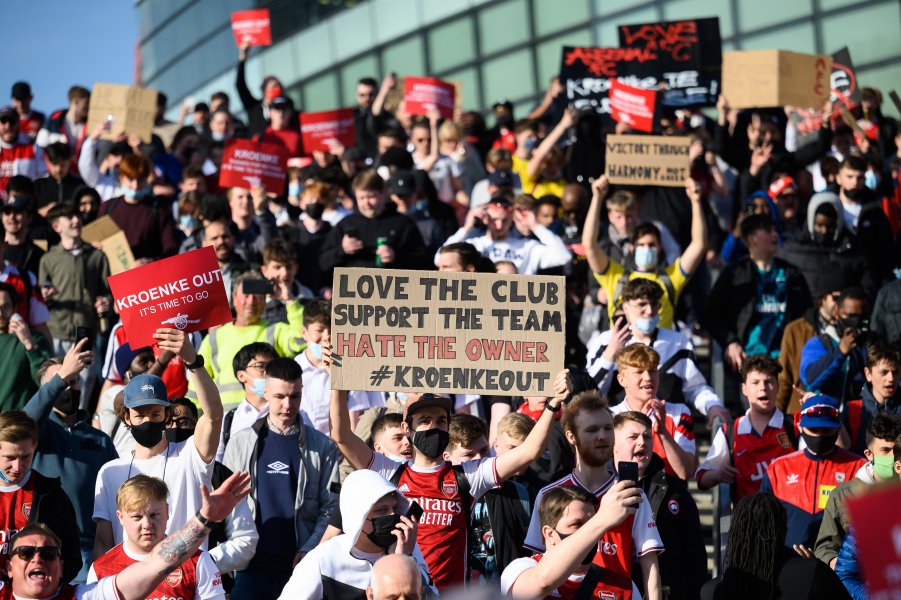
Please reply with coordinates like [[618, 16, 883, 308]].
[[153, 328, 222, 464]]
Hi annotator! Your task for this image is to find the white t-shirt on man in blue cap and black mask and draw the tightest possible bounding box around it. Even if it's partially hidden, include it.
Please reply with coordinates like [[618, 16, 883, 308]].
[[93, 436, 214, 550]]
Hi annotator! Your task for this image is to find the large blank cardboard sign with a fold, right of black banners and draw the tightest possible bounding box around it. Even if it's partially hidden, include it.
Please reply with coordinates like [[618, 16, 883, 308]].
[[723, 50, 832, 108]]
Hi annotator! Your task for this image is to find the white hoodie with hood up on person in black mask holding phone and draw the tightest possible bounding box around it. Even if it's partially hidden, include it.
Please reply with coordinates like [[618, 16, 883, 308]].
[[279, 469, 431, 600]]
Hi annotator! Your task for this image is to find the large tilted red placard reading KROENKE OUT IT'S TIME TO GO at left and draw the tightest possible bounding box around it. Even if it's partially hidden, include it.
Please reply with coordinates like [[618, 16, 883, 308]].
[[109, 246, 232, 348]]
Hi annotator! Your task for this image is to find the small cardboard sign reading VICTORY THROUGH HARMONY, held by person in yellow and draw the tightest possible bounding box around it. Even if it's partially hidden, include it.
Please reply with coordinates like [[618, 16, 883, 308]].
[[606, 135, 691, 187]]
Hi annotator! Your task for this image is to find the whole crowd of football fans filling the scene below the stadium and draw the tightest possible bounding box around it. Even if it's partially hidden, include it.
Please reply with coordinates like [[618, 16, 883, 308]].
[[0, 34, 901, 600]]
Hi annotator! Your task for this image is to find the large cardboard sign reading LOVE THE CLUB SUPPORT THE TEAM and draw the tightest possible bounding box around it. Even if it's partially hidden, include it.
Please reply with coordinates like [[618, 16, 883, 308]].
[[331, 269, 566, 396]]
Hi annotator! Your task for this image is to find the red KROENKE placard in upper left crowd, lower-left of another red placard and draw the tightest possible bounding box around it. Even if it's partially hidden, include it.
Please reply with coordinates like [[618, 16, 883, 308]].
[[219, 139, 288, 194]]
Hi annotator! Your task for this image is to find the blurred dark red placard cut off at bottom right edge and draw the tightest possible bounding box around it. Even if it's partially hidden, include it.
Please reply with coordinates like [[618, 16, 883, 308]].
[[847, 485, 901, 598]]
